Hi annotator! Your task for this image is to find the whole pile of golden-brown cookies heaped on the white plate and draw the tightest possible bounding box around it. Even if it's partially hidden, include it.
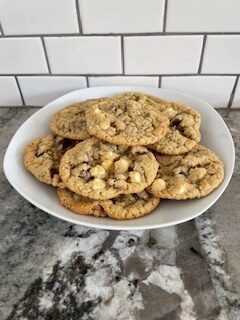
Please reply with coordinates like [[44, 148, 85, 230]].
[[24, 92, 224, 220]]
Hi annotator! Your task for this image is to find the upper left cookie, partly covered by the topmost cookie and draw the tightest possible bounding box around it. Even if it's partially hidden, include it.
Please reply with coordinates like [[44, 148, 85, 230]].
[[50, 98, 111, 140]]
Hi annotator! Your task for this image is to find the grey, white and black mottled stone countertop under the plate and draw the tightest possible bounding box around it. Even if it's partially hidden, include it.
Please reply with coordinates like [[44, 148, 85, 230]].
[[0, 108, 240, 320]]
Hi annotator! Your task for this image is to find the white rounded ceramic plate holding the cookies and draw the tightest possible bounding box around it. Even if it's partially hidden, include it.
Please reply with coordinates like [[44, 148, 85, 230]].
[[4, 86, 235, 230]]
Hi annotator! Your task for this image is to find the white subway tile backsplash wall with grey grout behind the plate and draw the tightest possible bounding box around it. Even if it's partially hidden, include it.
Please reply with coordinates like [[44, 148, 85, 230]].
[[0, 0, 240, 108]]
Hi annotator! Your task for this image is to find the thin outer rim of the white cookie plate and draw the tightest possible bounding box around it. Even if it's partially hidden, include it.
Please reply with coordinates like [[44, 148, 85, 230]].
[[3, 85, 235, 230]]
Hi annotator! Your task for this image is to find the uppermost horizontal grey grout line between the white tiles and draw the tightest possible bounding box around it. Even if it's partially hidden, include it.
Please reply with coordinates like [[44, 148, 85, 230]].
[[1, 32, 240, 38]]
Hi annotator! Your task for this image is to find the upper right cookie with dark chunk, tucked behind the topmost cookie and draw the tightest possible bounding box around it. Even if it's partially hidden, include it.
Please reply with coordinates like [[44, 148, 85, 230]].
[[117, 92, 201, 155]]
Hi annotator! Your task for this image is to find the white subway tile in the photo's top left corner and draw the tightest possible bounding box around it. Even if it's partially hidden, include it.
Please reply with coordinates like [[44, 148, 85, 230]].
[[0, 0, 79, 35]]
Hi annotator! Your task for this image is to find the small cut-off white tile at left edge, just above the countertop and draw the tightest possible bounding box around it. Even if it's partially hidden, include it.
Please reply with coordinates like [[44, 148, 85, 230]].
[[0, 77, 22, 107]]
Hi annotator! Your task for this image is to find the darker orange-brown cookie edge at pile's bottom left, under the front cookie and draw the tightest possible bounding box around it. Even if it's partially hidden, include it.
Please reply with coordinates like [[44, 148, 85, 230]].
[[57, 188, 106, 217]]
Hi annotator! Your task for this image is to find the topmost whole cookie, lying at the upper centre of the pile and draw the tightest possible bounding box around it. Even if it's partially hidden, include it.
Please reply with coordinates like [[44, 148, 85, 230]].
[[86, 99, 169, 146]]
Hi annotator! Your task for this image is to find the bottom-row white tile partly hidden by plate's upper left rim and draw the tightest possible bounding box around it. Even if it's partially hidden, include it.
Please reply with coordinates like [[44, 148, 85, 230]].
[[18, 76, 86, 106]]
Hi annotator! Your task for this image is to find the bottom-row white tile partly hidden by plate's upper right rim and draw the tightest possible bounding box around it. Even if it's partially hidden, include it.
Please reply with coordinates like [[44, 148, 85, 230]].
[[162, 76, 236, 108]]
